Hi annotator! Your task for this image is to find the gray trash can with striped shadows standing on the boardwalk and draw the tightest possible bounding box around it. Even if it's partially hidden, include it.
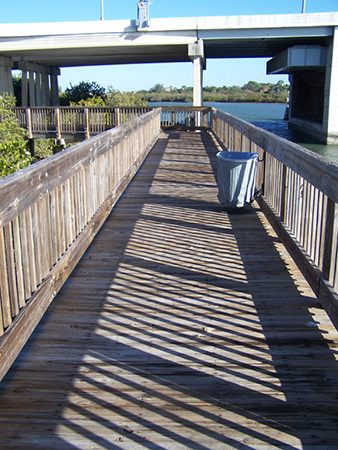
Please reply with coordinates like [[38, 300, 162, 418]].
[[217, 151, 258, 208]]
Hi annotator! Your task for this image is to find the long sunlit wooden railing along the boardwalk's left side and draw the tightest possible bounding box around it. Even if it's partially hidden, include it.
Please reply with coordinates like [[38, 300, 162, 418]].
[[0, 109, 161, 379]]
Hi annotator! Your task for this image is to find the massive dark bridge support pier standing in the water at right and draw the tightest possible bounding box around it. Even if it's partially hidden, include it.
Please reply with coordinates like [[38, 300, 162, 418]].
[[267, 44, 338, 144]]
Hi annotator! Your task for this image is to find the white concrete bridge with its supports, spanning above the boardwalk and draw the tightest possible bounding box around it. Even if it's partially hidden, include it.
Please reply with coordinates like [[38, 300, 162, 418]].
[[0, 13, 338, 143]]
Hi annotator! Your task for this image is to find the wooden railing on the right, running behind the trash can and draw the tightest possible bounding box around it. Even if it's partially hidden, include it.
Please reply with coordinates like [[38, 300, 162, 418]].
[[211, 110, 338, 328]]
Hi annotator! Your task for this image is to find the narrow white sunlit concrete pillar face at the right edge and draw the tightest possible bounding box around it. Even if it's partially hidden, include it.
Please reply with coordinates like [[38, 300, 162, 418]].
[[323, 27, 338, 144]]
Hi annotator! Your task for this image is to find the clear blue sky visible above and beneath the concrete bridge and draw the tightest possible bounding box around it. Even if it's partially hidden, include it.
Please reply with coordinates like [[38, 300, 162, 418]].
[[0, 0, 338, 91]]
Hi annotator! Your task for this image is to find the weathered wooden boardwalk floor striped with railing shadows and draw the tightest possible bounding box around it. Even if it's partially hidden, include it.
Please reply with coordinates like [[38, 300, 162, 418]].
[[0, 132, 338, 450]]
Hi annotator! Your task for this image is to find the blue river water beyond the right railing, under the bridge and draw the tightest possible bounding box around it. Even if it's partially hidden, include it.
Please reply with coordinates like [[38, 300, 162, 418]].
[[149, 102, 338, 164]]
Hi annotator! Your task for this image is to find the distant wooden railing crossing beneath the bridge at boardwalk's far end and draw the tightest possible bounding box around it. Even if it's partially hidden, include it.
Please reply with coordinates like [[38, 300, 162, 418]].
[[14, 106, 211, 140]]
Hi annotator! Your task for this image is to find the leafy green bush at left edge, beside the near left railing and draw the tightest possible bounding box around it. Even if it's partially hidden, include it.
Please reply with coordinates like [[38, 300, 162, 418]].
[[0, 93, 32, 177]]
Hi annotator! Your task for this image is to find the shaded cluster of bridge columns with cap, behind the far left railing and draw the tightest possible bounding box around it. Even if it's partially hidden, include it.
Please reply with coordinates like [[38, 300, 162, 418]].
[[16, 61, 60, 106]]
